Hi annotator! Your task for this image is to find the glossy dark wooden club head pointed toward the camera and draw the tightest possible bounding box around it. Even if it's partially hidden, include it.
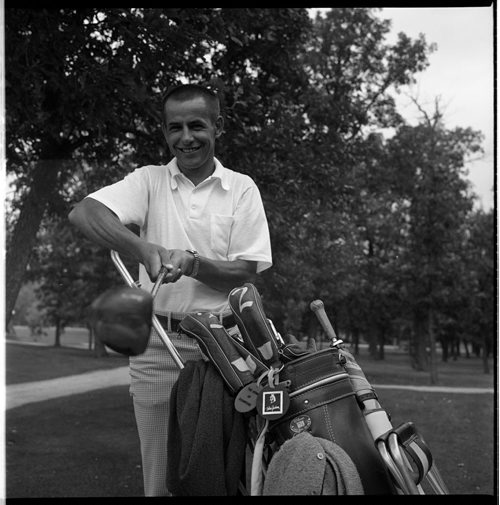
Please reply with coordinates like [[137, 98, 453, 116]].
[[89, 286, 153, 356]]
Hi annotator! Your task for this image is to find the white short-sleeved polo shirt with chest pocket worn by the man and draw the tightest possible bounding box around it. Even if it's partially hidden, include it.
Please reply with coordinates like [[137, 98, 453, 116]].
[[88, 158, 272, 314]]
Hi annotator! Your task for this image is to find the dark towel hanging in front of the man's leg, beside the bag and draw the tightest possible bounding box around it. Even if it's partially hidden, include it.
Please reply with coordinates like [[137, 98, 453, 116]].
[[167, 360, 247, 496]]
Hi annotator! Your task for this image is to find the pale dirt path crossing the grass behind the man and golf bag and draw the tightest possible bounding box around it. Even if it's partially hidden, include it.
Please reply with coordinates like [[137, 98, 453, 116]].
[[6, 366, 494, 410]]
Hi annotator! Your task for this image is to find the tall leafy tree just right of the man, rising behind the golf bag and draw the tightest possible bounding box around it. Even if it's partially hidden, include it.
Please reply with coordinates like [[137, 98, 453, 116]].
[[233, 9, 432, 329]]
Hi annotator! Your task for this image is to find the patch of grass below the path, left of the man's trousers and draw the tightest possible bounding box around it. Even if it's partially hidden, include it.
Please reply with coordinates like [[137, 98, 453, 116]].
[[5, 386, 143, 498]]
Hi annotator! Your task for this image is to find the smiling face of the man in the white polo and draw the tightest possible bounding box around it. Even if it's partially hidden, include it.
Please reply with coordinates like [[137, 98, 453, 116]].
[[163, 97, 223, 173]]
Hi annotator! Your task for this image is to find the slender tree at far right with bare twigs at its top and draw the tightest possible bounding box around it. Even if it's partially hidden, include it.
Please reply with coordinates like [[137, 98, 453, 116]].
[[389, 103, 481, 383]]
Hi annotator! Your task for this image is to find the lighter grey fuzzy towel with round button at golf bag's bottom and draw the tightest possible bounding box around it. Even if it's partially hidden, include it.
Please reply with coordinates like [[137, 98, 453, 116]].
[[262, 432, 364, 496]]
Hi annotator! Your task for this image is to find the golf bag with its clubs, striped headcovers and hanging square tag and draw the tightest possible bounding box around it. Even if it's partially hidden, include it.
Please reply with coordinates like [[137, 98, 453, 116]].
[[111, 251, 448, 495]]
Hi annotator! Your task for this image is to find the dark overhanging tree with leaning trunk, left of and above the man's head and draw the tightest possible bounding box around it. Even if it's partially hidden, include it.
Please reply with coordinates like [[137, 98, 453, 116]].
[[6, 9, 307, 330]]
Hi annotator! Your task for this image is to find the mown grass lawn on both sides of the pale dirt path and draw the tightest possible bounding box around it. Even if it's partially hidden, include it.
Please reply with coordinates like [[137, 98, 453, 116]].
[[5, 338, 497, 498]]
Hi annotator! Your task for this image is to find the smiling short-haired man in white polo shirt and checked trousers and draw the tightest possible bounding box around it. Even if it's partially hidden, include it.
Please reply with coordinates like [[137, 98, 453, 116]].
[[69, 80, 272, 496]]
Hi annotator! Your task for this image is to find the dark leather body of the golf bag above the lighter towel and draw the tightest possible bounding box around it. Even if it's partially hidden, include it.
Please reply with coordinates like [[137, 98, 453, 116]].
[[269, 348, 394, 494]]
